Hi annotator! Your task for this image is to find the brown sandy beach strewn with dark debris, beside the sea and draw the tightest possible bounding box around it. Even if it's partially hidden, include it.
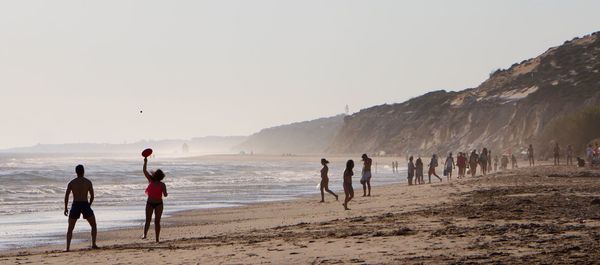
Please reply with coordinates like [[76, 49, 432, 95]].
[[0, 166, 600, 264]]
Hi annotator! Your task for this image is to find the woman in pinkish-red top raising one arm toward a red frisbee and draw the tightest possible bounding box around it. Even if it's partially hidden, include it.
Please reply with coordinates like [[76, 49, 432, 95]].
[[142, 157, 168, 243]]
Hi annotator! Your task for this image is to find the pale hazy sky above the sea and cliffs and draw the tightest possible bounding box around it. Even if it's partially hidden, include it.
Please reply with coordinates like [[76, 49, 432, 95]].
[[0, 0, 600, 148]]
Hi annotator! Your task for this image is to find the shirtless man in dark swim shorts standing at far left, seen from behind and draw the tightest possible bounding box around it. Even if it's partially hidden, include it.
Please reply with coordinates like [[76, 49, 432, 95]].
[[65, 165, 98, 251]]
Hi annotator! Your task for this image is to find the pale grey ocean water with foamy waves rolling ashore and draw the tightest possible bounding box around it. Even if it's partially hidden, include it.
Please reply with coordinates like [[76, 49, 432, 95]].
[[0, 154, 405, 250]]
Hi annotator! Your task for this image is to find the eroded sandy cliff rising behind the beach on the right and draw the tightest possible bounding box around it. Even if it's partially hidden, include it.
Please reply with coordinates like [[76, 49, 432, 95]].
[[327, 32, 600, 155]]
